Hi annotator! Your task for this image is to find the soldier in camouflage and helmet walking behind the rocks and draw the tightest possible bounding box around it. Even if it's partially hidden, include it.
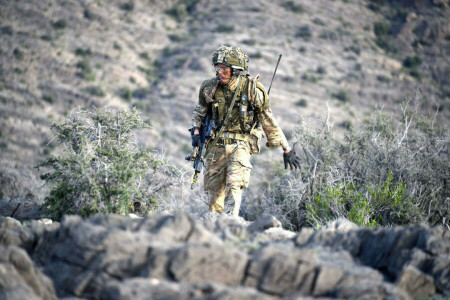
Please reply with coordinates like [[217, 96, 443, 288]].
[[189, 46, 300, 216]]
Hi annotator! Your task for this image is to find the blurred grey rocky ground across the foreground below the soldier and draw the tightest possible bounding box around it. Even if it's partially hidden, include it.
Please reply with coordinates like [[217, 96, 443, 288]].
[[0, 214, 450, 300]]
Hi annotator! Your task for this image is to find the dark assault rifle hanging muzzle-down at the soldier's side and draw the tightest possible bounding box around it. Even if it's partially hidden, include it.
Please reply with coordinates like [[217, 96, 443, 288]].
[[185, 114, 216, 189]]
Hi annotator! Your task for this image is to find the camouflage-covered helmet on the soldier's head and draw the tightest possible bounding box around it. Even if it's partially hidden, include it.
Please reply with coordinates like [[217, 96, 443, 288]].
[[212, 45, 248, 71]]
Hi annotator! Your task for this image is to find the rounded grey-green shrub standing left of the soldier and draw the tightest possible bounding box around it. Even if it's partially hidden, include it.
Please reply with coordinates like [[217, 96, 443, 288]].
[[39, 108, 181, 220]]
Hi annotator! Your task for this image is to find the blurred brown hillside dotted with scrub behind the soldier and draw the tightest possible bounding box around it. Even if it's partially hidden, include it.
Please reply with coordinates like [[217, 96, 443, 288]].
[[0, 0, 450, 204]]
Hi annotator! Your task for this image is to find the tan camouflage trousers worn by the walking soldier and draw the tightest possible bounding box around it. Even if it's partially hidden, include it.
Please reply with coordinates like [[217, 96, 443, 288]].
[[204, 141, 252, 216]]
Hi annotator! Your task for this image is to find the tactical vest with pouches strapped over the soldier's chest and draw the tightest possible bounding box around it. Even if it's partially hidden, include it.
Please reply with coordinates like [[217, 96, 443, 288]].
[[212, 75, 268, 133]]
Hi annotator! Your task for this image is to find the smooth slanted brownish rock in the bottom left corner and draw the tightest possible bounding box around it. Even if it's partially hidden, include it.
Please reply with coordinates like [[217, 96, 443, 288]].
[[0, 245, 57, 300]]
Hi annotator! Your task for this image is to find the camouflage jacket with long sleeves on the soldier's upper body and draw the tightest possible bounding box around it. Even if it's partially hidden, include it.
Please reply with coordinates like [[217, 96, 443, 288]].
[[190, 76, 288, 148]]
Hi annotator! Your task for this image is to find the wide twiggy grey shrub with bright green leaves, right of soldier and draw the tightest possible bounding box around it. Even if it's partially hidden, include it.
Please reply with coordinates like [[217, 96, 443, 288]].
[[258, 101, 450, 230]]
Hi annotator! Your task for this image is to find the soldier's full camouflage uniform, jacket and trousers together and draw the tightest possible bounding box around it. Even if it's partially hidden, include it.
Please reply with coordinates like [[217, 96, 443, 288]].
[[191, 45, 288, 215]]
